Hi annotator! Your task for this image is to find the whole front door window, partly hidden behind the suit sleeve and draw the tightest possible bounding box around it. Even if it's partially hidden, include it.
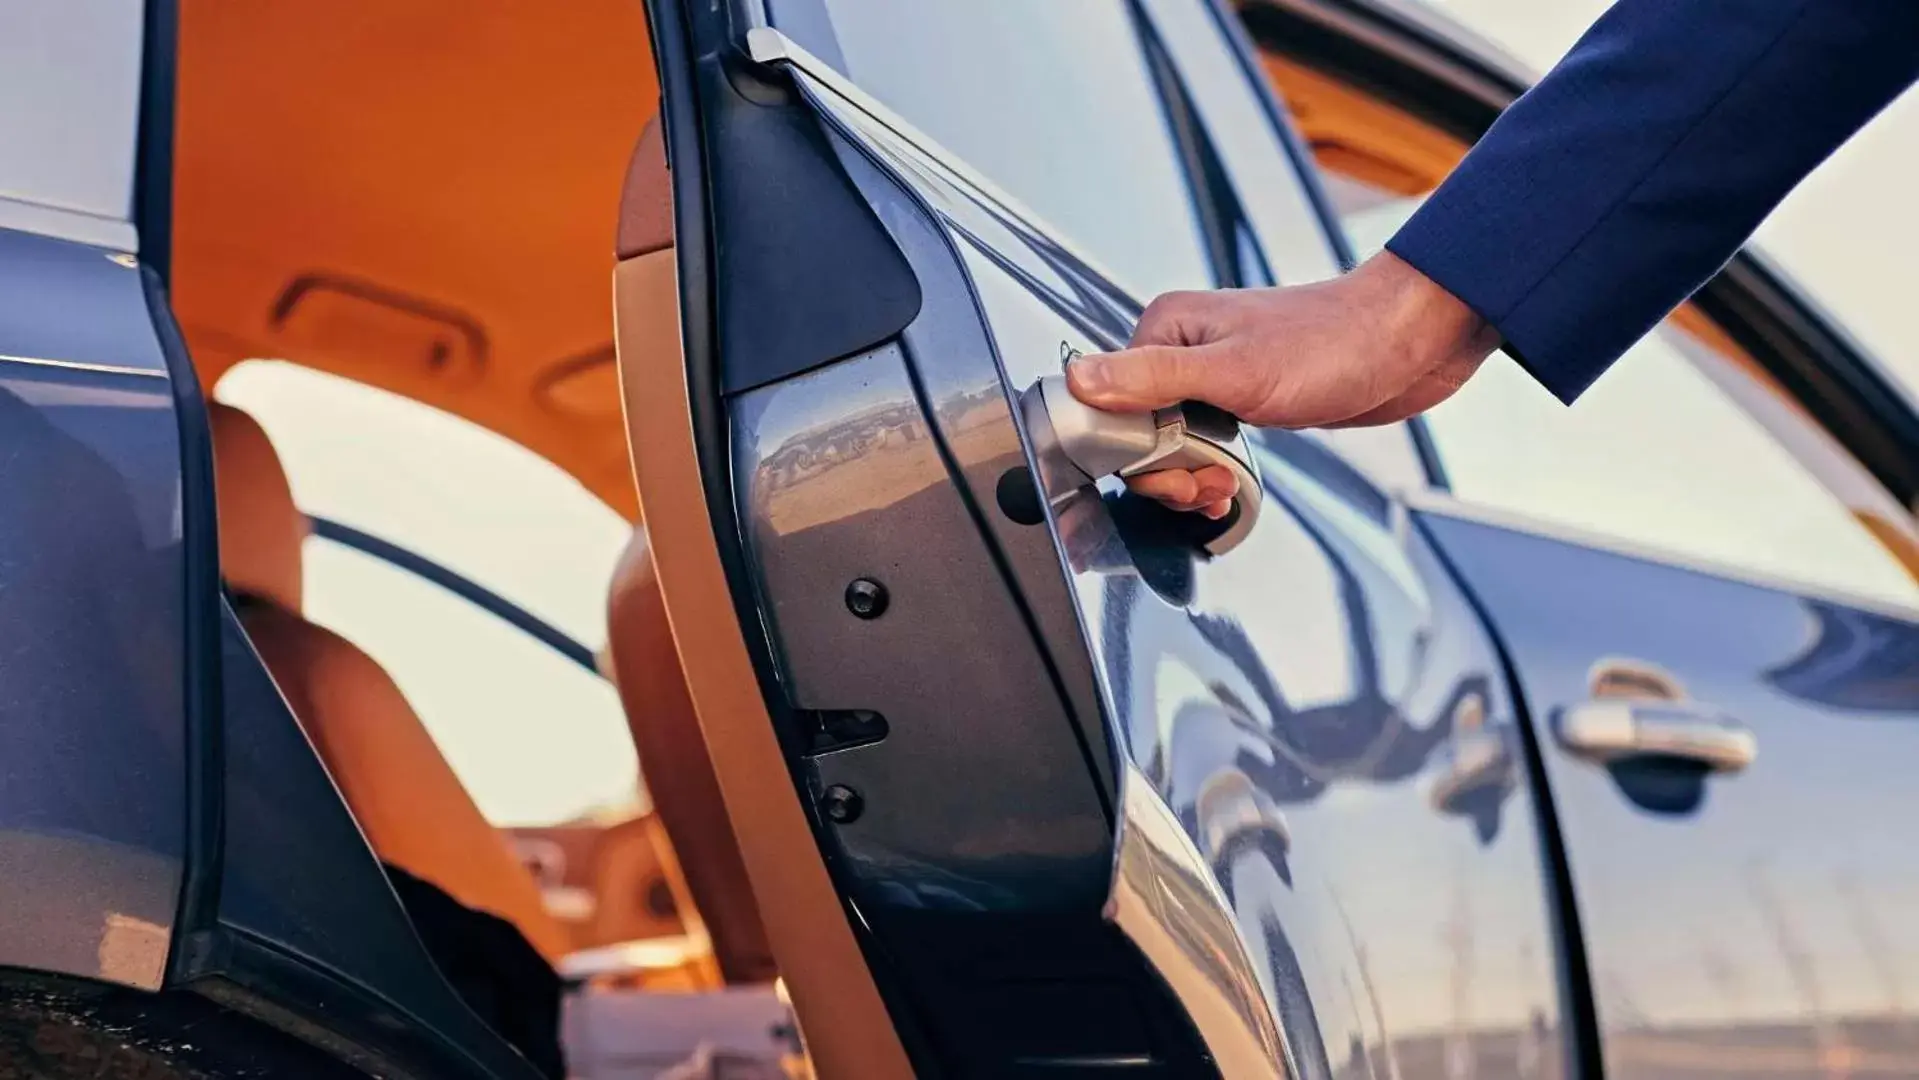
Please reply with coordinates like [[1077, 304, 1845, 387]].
[[1268, 65, 1919, 604]]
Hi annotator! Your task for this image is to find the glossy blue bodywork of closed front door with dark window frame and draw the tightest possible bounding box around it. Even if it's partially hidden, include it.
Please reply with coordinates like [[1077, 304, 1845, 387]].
[[1244, 0, 1919, 1078]]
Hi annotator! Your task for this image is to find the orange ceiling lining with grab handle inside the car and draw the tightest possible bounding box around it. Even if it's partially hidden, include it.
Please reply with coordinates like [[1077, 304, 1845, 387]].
[[171, 0, 658, 518]]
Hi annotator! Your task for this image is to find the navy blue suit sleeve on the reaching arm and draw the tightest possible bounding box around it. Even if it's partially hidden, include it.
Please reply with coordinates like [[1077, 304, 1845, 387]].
[[1386, 0, 1919, 403]]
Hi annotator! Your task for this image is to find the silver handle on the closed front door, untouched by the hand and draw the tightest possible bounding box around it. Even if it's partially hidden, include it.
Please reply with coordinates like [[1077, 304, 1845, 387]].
[[1552, 700, 1760, 773]]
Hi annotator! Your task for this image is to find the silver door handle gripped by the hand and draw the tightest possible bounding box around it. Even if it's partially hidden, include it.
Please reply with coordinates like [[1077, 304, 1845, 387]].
[[1019, 376, 1261, 554]]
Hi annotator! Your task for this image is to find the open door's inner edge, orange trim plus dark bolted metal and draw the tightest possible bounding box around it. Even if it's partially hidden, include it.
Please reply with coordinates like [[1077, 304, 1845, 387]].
[[616, 2, 1235, 1078]]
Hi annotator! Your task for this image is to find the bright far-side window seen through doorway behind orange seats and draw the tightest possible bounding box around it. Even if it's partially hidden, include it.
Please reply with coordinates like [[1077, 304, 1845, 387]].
[[217, 361, 645, 827]]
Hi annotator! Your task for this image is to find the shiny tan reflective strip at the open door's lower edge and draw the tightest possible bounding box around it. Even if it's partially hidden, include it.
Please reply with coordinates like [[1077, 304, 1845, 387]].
[[1105, 762, 1297, 1080]]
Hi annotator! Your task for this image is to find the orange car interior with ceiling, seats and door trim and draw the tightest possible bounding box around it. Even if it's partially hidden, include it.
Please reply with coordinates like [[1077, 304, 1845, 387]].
[[171, 0, 912, 1078]]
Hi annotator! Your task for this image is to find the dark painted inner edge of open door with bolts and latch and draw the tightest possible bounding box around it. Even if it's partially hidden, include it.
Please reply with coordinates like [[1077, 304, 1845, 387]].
[[727, 82, 1201, 1076]]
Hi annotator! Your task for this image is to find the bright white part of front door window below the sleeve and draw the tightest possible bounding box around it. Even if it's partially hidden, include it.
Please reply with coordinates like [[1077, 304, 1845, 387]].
[[1426, 326, 1919, 604]]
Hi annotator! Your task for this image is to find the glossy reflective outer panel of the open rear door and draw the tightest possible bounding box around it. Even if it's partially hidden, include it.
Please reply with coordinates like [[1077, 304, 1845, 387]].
[[735, 12, 1570, 1076]]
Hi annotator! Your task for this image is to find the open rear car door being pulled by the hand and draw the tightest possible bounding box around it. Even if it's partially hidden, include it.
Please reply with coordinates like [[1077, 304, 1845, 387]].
[[612, 0, 1558, 1078]]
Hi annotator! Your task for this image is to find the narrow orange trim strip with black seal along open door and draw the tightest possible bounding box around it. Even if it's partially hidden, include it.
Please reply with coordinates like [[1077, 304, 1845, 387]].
[[612, 2, 913, 1080]]
